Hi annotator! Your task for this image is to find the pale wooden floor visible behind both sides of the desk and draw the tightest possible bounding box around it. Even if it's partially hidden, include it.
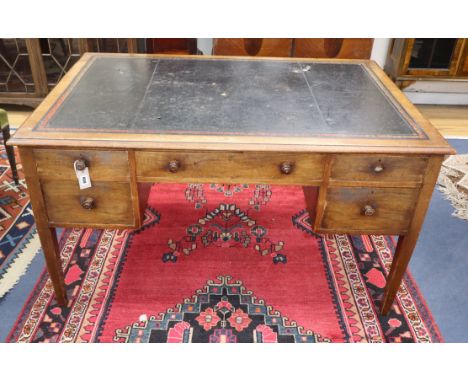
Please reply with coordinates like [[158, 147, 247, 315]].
[[0, 105, 468, 138]]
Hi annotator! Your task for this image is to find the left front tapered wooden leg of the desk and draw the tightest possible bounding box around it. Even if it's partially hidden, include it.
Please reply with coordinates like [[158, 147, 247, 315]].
[[19, 147, 67, 306]]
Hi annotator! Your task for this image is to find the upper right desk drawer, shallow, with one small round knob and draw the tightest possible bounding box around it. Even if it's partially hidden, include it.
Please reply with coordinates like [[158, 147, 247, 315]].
[[331, 155, 428, 183]]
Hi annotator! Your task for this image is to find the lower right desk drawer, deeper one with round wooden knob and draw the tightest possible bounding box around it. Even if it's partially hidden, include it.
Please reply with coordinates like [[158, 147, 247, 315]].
[[316, 187, 419, 234]]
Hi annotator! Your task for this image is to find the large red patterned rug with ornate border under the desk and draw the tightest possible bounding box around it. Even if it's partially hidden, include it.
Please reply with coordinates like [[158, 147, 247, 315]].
[[8, 184, 442, 342]]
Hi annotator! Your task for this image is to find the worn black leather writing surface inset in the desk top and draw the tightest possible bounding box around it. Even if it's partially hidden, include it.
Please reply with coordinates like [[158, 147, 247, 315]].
[[33, 56, 426, 139]]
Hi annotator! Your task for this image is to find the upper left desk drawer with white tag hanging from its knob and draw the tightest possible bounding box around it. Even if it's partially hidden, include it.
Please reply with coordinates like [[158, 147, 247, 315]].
[[34, 149, 130, 182]]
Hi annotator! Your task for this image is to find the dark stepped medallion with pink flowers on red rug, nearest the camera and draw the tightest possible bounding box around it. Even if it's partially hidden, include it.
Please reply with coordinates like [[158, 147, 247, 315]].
[[114, 276, 329, 343]]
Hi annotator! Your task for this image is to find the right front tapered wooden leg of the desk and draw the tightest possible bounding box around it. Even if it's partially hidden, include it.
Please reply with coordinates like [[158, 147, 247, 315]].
[[381, 156, 443, 315]]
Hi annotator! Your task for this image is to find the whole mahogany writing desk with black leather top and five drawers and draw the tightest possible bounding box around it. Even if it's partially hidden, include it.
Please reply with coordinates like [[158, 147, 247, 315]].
[[10, 54, 454, 314]]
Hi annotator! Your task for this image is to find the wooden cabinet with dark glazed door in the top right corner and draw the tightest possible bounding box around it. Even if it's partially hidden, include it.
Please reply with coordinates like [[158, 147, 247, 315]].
[[385, 38, 468, 88]]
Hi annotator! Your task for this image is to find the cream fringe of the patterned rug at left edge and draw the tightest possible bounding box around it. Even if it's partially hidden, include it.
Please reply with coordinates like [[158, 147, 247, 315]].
[[0, 233, 41, 299]]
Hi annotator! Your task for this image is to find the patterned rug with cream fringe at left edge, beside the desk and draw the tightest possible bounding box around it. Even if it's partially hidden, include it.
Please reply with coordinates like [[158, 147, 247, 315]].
[[0, 146, 40, 301]]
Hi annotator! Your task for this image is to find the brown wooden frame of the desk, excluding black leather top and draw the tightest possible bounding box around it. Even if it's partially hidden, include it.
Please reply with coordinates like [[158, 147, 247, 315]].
[[9, 54, 454, 314]]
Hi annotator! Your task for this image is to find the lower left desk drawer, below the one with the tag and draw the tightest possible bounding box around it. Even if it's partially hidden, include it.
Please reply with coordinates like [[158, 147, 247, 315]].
[[41, 180, 134, 227]]
